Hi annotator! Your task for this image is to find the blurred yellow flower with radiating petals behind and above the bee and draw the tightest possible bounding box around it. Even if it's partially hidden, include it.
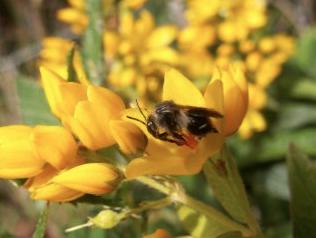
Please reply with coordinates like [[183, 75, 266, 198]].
[[104, 11, 178, 100]]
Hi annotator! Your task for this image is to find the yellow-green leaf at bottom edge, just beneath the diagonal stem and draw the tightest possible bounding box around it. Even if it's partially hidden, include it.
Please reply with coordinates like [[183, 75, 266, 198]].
[[177, 205, 236, 238]]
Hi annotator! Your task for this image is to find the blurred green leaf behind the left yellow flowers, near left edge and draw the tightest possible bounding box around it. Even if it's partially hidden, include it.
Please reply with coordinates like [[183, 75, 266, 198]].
[[17, 78, 59, 125]]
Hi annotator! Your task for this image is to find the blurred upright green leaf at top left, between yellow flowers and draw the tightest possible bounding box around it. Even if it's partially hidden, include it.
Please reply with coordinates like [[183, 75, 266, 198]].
[[82, 0, 105, 85]]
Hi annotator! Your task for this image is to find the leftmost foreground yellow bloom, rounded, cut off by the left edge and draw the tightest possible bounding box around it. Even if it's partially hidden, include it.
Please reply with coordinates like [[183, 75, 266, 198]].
[[0, 125, 77, 179]]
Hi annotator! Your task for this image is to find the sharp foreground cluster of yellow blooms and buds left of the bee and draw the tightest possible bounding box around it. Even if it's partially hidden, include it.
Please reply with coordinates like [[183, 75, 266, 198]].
[[0, 67, 147, 202]]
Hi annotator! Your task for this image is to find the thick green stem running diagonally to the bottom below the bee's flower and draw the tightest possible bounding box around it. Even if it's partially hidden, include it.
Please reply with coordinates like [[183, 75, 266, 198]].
[[137, 177, 253, 237]]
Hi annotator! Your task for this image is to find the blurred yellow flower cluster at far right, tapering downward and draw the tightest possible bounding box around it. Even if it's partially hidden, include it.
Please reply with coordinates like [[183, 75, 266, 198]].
[[239, 34, 295, 138]]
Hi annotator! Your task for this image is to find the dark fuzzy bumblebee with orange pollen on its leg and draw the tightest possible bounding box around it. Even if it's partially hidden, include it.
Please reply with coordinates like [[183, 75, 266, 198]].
[[127, 100, 223, 149]]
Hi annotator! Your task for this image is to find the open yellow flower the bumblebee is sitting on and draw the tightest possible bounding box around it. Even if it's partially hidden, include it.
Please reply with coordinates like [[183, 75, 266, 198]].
[[126, 68, 247, 178]]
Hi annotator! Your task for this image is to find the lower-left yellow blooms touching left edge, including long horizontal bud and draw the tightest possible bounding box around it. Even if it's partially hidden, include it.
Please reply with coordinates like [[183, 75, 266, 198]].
[[0, 125, 120, 201]]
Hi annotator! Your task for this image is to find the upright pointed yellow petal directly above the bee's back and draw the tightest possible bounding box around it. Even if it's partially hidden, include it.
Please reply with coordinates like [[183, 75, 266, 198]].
[[162, 69, 205, 107]]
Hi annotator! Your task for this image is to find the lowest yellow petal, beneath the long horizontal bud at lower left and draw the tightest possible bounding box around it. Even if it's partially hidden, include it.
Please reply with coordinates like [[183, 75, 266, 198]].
[[31, 183, 84, 202]]
